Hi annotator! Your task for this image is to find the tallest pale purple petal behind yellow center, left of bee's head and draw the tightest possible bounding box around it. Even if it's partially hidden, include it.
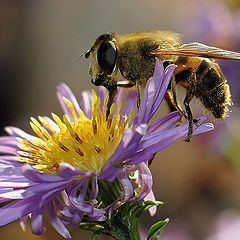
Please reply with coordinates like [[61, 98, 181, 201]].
[[57, 83, 80, 121]]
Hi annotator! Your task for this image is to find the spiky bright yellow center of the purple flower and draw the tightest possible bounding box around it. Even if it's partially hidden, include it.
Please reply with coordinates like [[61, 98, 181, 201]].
[[16, 91, 132, 174]]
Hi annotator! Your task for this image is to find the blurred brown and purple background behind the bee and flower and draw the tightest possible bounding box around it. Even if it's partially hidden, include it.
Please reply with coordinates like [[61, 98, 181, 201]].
[[0, 0, 240, 240]]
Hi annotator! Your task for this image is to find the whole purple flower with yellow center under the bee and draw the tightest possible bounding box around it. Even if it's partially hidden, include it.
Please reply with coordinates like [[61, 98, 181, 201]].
[[0, 61, 213, 238]]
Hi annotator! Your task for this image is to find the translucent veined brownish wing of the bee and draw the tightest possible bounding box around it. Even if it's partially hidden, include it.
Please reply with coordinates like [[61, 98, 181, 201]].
[[151, 42, 240, 60]]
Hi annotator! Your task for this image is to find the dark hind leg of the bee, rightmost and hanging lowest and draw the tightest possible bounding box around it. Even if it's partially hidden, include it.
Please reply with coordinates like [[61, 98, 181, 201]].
[[183, 72, 197, 142]]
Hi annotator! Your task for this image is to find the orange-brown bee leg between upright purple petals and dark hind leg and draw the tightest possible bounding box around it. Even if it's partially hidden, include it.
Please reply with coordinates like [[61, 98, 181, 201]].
[[170, 75, 188, 119]]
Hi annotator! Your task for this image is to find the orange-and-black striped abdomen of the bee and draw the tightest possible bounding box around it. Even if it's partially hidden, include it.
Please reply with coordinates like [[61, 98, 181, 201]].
[[175, 57, 231, 118]]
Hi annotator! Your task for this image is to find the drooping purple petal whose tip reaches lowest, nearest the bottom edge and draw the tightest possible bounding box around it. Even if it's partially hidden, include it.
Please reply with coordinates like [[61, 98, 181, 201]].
[[45, 203, 71, 239]]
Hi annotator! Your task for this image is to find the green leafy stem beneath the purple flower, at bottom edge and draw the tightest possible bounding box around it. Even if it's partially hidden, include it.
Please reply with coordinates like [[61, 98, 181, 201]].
[[79, 201, 165, 240]]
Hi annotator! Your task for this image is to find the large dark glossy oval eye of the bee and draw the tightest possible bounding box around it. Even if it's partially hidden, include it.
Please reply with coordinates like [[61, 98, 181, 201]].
[[97, 41, 117, 75]]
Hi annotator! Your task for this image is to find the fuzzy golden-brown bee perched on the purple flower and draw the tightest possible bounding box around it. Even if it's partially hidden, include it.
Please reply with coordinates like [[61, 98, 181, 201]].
[[85, 31, 240, 142]]
